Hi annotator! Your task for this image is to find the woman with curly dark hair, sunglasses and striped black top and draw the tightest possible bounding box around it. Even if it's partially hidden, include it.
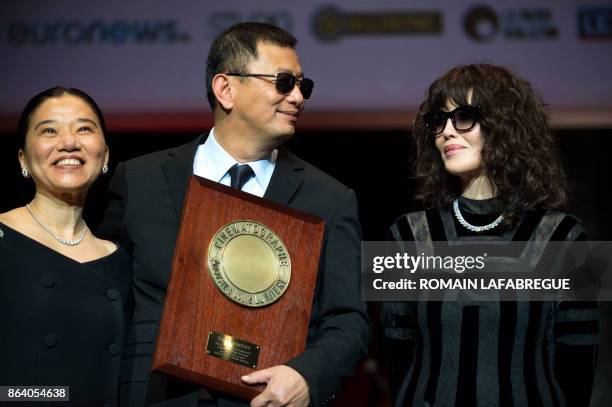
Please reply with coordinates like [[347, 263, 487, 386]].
[[383, 64, 598, 407]]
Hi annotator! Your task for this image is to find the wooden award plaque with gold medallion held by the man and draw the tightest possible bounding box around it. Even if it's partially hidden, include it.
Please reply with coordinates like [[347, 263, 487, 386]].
[[152, 176, 324, 400]]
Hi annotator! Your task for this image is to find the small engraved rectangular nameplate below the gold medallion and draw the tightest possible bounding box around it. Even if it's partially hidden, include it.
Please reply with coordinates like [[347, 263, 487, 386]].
[[206, 331, 259, 369]]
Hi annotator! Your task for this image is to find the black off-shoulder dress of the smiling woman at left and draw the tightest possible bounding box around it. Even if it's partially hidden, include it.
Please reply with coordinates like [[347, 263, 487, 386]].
[[0, 223, 132, 407]]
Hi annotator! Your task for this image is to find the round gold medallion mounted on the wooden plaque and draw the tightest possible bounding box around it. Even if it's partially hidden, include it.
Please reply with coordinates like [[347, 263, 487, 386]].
[[208, 220, 291, 307]]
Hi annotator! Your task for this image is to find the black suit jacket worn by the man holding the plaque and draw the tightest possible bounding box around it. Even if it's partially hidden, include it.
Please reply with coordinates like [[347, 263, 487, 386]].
[[99, 135, 370, 406]]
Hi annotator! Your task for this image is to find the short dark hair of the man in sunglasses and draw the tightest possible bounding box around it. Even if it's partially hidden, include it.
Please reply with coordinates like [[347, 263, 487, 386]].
[[206, 22, 297, 110]]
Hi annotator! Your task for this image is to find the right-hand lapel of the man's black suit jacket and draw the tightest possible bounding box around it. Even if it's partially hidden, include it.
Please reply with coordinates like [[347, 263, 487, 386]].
[[264, 147, 304, 205]]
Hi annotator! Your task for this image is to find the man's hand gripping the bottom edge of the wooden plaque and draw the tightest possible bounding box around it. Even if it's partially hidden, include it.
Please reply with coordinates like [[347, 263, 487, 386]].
[[241, 365, 310, 407]]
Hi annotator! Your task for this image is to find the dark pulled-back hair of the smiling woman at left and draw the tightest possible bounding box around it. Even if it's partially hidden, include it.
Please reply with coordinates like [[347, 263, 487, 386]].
[[17, 86, 106, 148]]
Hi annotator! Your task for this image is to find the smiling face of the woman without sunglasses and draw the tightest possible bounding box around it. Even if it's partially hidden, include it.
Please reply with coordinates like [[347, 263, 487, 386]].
[[19, 94, 108, 196]]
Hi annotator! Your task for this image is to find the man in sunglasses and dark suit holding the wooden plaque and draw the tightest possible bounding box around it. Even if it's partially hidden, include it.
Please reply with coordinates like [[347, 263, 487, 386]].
[[99, 23, 369, 406]]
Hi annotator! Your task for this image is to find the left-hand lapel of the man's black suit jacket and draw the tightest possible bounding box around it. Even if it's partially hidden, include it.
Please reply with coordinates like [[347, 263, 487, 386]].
[[162, 133, 208, 219]]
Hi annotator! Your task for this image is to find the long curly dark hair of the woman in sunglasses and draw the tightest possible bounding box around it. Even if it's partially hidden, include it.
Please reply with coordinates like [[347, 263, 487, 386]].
[[412, 64, 567, 220]]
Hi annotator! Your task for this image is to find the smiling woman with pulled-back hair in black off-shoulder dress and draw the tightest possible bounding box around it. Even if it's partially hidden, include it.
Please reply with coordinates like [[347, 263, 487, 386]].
[[0, 87, 131, 406]]
